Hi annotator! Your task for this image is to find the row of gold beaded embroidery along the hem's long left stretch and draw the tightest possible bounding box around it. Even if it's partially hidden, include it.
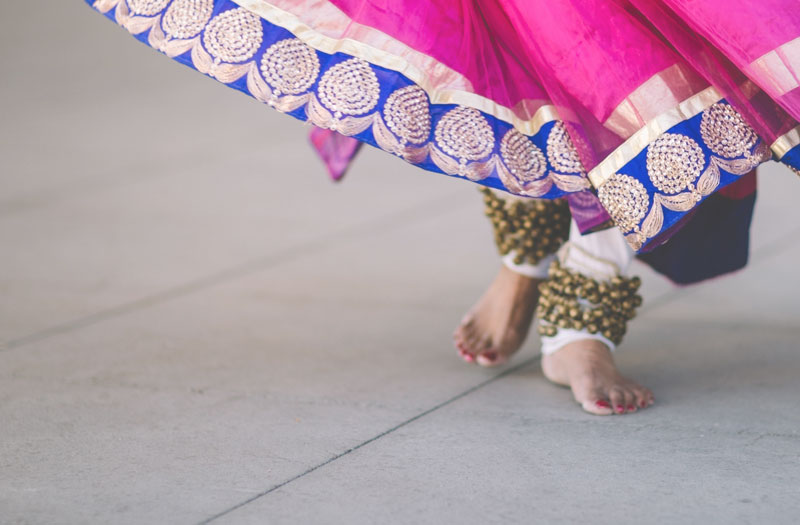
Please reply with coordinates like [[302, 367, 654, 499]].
[[94, 0, 600, 197]]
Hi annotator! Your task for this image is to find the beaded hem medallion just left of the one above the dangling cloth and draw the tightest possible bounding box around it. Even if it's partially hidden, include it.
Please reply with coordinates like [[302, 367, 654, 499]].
[[261, 38, 319, 95]]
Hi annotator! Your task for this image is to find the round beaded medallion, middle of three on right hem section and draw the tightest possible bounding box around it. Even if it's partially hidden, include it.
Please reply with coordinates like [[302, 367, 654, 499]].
[[648, 133, 706, 195]]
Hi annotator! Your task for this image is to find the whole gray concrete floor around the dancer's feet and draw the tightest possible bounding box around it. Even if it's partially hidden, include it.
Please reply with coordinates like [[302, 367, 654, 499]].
[[0, 1, 800, 524]]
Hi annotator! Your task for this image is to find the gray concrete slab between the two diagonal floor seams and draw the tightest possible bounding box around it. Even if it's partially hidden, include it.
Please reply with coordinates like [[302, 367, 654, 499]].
[[0, 202, 512, 523]]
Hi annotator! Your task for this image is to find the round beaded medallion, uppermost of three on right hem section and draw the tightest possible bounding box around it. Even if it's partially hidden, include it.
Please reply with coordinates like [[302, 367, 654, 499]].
[[700, 103, 758, 159]]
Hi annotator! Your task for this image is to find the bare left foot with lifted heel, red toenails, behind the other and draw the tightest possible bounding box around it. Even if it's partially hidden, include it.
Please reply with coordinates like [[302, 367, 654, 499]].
[[453, 266, 541, 366]]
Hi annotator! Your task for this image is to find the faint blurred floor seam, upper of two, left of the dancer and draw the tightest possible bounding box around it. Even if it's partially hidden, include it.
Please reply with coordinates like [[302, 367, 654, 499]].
[[0, 189, 466, 352]]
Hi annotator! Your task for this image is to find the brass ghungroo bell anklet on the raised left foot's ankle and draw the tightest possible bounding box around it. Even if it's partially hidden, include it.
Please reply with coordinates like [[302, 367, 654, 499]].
[[481, 188, 570, 264]]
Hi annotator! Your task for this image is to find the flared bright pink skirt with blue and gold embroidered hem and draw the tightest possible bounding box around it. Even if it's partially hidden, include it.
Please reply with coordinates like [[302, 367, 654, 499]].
[[88, 0, 800, 251]]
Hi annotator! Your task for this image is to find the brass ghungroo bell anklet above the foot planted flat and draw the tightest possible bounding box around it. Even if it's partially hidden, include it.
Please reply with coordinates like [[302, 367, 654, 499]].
[[536, 260, 642, 345]]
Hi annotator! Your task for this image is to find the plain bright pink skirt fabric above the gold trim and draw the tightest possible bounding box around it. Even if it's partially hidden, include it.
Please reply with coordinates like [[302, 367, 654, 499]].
[[322, 0, 800, 156]]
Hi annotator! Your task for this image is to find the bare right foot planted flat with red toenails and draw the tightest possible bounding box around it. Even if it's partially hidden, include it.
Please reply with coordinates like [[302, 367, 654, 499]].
[[542, 339, 653, 416]]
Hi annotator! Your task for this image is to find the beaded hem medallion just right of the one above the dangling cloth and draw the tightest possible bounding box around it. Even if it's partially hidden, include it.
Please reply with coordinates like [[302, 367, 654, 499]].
[[383, 85, 431, 144]]
